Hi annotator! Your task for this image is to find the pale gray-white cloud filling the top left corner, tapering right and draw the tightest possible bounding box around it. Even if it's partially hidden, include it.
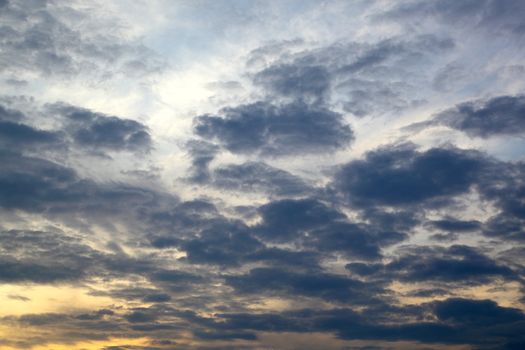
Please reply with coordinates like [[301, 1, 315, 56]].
[[0, 1, 164, 79]]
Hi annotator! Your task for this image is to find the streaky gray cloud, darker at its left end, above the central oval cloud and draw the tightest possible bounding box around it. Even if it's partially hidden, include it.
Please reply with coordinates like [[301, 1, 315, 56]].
[[251, 35, 455, 117]]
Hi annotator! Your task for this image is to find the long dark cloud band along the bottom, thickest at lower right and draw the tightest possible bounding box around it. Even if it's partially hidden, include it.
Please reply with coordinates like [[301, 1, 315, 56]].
[[4, 298, 524, 349]]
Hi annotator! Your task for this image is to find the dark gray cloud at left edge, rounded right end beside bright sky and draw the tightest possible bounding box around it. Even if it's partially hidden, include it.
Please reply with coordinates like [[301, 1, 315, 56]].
[[0, 103, 152, 153]]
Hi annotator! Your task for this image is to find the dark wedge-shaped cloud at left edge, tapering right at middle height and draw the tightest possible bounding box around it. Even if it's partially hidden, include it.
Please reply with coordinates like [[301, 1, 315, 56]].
[[0, 152, 164, 216]]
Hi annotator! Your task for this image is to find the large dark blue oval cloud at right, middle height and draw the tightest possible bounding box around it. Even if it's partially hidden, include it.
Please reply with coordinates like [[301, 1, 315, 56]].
[[334, 145, 486, 207]]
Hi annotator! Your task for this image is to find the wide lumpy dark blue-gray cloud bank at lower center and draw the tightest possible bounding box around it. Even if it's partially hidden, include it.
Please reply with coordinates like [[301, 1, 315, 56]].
[[150, 199, 408, 268]]
